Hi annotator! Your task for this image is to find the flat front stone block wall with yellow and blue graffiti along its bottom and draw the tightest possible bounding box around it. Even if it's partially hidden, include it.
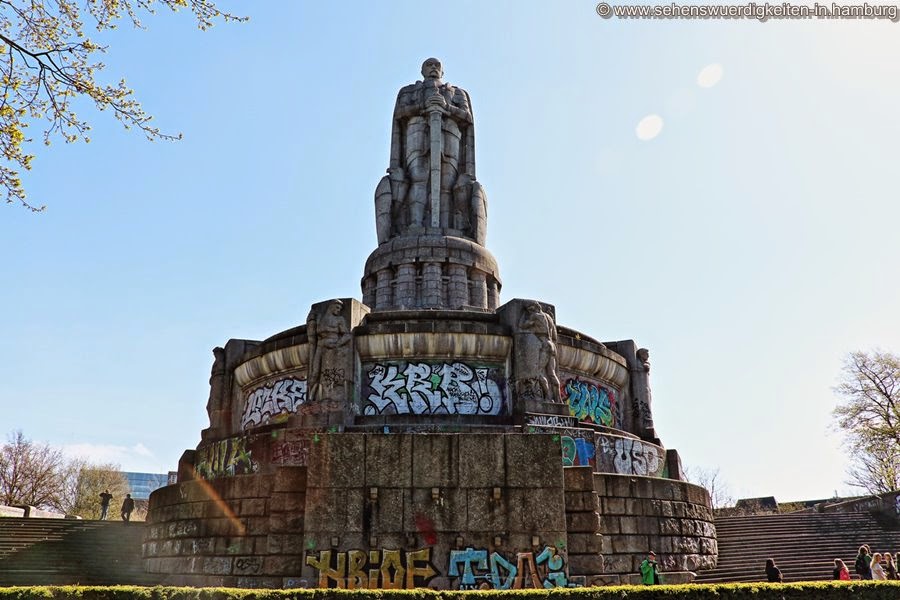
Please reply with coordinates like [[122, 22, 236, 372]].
[[303, 434, 566, 589]]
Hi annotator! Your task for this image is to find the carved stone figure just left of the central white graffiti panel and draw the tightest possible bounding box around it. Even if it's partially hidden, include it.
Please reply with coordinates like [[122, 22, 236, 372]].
[[306, 300, 353, 401]]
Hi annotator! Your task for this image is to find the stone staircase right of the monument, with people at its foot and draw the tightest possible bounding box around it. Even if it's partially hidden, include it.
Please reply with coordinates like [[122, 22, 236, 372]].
[[695, 512, 900, 583]]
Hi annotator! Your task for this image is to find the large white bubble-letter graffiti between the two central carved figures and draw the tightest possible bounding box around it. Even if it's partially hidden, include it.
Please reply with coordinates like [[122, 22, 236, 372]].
[[362, 362, 504, 415]]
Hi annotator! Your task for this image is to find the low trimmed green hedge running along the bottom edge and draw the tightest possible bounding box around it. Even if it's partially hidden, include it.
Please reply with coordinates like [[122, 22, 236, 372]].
[[0, 581, 900, 600]]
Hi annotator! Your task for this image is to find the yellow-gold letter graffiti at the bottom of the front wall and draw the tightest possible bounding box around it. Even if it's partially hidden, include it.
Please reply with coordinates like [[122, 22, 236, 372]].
[[306, 548, 438, 590]]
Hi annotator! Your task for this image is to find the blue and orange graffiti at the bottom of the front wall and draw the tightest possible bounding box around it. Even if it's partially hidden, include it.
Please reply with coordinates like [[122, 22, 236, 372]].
[[447, 546, 575, 590]]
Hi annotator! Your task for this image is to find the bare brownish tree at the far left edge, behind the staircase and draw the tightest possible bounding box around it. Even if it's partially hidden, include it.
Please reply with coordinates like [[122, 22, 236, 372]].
[[0, 431, 65, 509]]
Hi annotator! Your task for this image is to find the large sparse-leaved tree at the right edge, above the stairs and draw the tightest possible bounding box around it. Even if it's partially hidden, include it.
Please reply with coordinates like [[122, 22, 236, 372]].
[[833, 350, 900, 494]]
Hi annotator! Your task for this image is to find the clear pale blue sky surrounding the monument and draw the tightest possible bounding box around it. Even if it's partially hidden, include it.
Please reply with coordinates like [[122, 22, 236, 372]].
[[0, 0, 900, 500]]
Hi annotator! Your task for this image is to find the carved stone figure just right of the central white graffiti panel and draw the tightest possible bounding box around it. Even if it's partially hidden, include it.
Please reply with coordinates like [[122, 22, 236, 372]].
[[515, 302, 561, 402]]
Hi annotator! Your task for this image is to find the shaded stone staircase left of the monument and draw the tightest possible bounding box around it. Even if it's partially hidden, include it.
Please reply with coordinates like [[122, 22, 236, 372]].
[[0, 518, 160, 586]]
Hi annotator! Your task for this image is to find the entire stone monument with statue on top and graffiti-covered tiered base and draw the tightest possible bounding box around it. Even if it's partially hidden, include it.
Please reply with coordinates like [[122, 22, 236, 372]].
[[144, 59, 717, 589]]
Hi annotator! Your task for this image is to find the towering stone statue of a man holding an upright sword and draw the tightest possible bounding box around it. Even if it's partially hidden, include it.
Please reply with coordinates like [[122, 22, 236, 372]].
[[375, 58, 487, 245]]
